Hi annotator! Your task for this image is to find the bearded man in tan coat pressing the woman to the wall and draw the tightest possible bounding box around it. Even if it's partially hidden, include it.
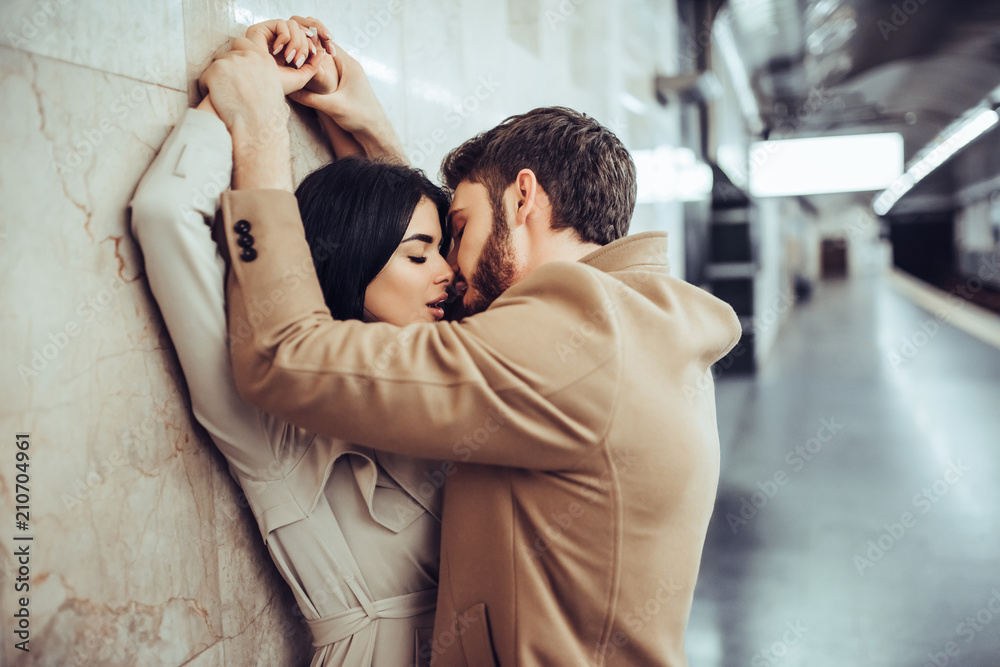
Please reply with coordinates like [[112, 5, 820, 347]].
[[202, 30, 740, 667]]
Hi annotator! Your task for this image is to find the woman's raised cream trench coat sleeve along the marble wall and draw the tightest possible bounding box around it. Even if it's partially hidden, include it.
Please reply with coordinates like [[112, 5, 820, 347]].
[[129, 109, 277, 479]]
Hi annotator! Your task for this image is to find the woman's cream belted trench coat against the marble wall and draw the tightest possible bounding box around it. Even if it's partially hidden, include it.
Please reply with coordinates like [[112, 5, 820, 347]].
[[130, 109, 443, 667]]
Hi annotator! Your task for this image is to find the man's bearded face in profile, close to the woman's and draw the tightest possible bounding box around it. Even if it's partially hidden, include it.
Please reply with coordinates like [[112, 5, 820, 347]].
[[448, 181, 520, 315]]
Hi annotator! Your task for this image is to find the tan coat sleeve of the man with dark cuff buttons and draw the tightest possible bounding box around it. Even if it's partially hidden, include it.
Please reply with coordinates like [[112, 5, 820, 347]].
[[216, 190, 620, 470]]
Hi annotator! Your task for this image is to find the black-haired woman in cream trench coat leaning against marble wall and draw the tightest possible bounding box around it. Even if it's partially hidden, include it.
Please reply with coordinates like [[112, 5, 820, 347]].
[[130, 22, 453, 667]]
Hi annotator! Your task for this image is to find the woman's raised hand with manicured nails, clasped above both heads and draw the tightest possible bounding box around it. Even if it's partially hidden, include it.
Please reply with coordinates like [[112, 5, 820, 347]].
[[246, 17, 336, 95]]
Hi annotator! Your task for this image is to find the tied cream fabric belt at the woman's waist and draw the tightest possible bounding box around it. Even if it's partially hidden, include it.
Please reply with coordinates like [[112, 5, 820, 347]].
[[306, 577, 437, 648]]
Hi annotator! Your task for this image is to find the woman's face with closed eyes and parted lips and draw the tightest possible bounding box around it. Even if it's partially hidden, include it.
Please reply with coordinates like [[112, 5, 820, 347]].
[[365, 197, 455, 326]]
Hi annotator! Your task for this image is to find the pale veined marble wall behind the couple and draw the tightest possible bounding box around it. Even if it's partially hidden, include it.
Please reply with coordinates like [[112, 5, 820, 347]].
[[0, 0, 683, 667]]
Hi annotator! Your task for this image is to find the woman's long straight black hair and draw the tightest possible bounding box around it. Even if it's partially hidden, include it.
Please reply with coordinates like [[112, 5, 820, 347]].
[[295, 158, 451, 320]]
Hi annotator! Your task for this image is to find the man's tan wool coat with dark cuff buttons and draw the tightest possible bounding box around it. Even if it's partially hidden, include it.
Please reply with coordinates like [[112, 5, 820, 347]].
[[216, 185, 740, 667]]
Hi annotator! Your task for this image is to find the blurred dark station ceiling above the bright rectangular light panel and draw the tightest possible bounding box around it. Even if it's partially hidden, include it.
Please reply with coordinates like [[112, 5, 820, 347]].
[[707, 0, 1000, 206]]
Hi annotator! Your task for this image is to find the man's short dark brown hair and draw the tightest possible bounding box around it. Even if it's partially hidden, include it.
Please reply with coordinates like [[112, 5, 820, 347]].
[[441, 107, 636, 245]]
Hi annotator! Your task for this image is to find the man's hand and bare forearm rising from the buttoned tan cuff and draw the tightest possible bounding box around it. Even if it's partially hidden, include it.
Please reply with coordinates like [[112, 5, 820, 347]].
[[199, 37, 292, 191]]
